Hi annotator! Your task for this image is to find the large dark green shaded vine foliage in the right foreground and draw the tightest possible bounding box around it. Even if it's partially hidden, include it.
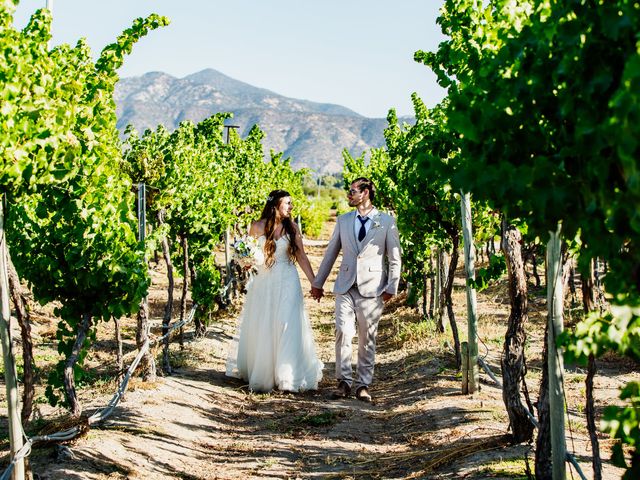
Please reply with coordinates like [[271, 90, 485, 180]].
[[416, 0, 640, 472]]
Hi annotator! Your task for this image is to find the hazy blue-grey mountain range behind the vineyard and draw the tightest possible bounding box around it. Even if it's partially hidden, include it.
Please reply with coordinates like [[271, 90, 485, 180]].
[[115, 69, 398, 174]]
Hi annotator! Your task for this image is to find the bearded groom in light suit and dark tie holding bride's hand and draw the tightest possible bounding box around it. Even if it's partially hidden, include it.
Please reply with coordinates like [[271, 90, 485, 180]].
[[311, 177, 400, 402]]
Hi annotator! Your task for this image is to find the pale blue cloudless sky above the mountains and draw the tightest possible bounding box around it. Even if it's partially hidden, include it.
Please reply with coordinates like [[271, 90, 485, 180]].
[[14, 0, 444, 117]]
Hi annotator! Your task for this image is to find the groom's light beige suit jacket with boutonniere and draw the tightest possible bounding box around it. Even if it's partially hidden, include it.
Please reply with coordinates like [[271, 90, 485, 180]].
[[313, 210, 401, 297]]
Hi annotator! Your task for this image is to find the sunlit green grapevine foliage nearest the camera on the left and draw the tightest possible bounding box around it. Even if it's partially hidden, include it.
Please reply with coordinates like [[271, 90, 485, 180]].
[[0, 2, 167, 403]]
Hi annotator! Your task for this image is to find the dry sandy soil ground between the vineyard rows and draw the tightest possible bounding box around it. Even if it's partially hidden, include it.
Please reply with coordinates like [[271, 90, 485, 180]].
[[2, 216, 640, 480]]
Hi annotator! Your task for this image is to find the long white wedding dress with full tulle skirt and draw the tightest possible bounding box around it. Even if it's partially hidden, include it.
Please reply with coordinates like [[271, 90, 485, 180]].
[[226, 235, 324, 392]]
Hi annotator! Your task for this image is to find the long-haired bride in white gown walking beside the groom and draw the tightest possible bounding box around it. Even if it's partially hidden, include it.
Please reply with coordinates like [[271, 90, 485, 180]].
[[226, 190, 323, 392]]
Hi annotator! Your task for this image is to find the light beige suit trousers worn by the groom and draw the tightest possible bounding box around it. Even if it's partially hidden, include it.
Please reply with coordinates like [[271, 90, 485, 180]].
[[336, 286, 384, 390]]
